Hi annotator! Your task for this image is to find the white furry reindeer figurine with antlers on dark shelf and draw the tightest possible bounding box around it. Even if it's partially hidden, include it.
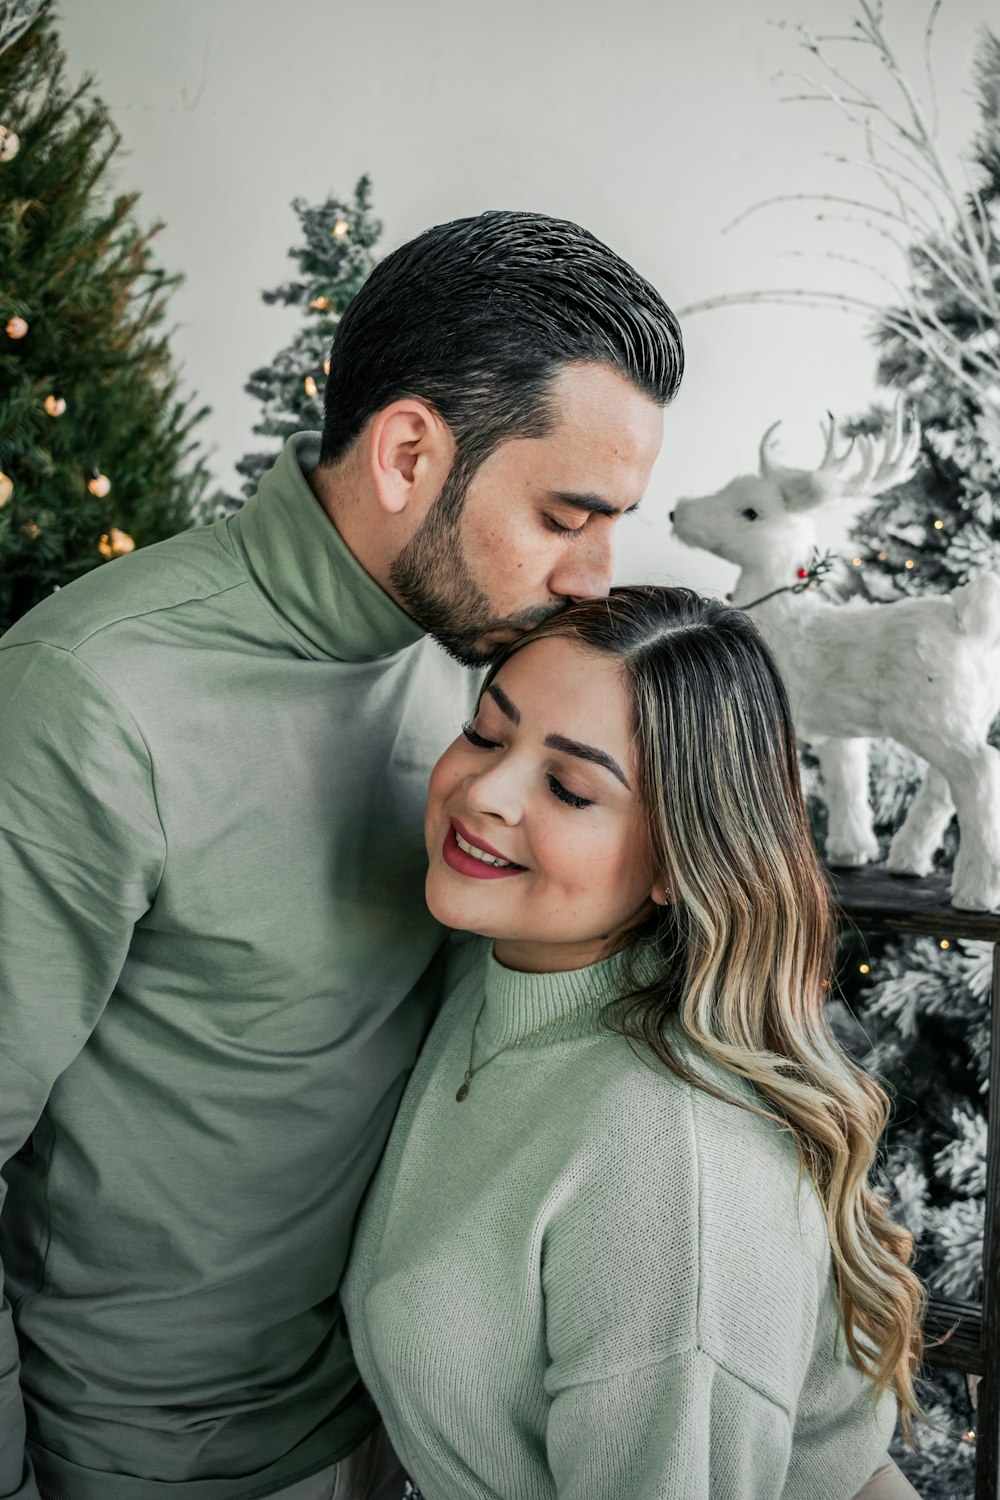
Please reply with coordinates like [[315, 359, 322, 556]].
[[670, 405, 1000, 911]]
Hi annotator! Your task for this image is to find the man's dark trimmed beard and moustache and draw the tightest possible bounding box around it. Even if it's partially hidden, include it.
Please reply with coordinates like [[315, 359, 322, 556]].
[[388, 464, 564, 666]]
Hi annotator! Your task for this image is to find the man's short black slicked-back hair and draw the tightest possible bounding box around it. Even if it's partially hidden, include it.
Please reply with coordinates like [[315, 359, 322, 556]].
[[319, 212, 684, 480]]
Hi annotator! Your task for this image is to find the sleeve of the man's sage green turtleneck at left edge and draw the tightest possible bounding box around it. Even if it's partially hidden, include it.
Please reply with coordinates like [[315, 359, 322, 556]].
[[0, 642, 165, 1500]]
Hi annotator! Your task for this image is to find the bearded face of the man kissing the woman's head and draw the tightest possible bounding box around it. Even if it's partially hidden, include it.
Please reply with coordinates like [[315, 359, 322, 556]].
[[390, 365, 663, 666]]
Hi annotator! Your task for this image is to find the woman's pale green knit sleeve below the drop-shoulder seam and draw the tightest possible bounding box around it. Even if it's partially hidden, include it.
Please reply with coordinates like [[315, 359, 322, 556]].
[[547, 1349, 792, 1500]]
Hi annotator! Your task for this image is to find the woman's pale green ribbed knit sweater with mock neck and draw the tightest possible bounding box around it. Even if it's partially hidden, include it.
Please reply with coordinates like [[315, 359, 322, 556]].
[[342, 939, 897, 1500]]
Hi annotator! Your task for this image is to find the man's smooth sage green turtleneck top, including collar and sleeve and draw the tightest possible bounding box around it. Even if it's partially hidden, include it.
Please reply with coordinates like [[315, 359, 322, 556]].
[[0, 435, 474, 1500]]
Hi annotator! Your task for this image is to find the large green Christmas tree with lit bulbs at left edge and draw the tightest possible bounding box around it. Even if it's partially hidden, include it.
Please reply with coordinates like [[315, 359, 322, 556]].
[[0, 0, 207, 630]]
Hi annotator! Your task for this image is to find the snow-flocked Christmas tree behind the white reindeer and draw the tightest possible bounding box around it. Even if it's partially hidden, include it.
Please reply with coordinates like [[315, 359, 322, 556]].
[[839, 32, 1000, 1500]]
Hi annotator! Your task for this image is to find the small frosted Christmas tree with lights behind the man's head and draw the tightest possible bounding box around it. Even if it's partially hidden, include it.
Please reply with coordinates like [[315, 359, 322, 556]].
[[222, 177, 382, 510]]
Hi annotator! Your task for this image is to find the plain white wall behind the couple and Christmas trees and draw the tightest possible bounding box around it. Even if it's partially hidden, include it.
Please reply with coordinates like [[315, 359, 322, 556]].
[[61, 0, 996, 591]]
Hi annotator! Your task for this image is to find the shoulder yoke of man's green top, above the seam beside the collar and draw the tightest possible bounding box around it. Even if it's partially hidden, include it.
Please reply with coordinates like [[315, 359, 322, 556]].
[[0, 527, 244, 651]]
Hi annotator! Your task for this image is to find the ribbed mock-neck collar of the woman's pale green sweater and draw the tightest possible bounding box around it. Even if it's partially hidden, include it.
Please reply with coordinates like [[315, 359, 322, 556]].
[[477, 948, 655, 1053]]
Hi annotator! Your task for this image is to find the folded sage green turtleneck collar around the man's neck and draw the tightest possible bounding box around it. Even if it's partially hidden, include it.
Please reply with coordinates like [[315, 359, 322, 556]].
[[226, 432, 423, 662]]
